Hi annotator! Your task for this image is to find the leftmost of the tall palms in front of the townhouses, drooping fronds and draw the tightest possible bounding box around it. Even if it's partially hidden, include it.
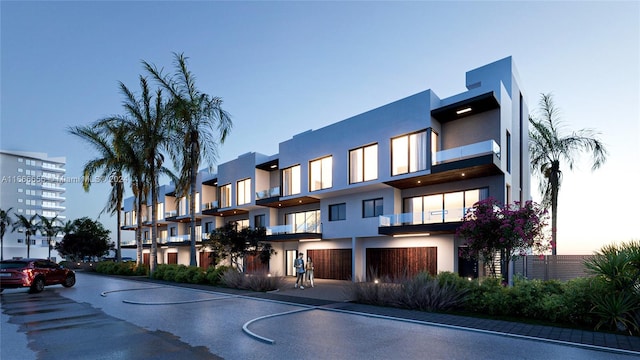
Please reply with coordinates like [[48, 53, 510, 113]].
[[68, 124, 127, 261]]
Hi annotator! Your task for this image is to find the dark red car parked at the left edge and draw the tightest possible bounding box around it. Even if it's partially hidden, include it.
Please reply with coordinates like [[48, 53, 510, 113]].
[[0, 259, 76, 293]]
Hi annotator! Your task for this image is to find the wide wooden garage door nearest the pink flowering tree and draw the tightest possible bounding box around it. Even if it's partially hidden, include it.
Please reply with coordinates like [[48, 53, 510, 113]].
[[367, 247, 438, 281]]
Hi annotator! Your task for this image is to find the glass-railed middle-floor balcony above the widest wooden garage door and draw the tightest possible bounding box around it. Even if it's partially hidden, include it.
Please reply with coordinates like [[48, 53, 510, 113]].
[[378, 208, 468, 236]]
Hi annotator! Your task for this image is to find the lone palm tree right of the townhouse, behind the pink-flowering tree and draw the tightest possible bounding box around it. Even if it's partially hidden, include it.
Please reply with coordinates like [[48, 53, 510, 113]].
[[529, 94, 607, 255]]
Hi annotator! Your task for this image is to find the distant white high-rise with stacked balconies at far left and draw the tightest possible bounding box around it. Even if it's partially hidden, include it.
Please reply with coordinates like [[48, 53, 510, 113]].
[[0, 150, 66, 260]]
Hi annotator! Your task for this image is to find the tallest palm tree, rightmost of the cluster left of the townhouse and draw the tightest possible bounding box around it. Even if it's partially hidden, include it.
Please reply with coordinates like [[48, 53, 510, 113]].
[[143, 53, 232, 266]]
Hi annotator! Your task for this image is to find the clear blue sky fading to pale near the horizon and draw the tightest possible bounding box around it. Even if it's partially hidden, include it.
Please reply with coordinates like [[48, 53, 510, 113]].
[[0, 0, 640, 254]]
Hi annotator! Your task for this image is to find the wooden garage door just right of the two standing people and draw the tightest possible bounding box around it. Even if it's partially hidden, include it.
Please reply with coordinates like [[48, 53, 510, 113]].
[[304, 249, 351, 280]]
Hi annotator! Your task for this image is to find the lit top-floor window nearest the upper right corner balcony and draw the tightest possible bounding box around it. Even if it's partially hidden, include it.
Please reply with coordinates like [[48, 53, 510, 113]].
[[391, 131, 427, 175]]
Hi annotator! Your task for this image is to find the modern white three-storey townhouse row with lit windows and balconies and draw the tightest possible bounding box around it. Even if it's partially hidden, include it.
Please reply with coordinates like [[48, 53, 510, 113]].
[[125, 57, 530, 280]]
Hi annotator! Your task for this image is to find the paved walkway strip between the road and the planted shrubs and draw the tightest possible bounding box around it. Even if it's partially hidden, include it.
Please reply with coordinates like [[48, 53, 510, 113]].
[[124, 278, 640, 356]]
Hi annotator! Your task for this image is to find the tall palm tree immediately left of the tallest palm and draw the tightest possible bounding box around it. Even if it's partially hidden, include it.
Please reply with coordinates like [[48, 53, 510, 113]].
[[112, 76, 173, 274]]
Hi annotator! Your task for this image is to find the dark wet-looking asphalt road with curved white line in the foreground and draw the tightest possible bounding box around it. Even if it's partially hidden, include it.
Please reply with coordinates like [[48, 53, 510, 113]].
[[0, 273, 637, 360]]
